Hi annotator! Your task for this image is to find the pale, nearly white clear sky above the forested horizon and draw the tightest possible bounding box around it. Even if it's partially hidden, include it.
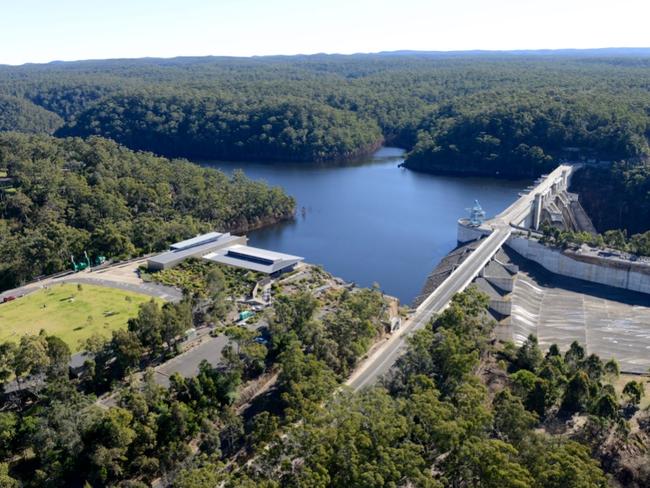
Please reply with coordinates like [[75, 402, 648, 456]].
[[0, 0, 650, 64]]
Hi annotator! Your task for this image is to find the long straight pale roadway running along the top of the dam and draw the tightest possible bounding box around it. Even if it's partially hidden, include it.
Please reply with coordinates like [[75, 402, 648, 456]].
[[346, 165, 574, 391]]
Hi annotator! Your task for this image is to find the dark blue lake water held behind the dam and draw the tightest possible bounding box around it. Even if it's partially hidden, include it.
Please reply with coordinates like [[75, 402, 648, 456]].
[[202, 147, 529, 303]]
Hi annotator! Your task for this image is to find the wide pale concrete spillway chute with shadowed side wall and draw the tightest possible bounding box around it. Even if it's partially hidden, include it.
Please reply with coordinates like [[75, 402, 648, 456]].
[[496, 248, 650, 373]]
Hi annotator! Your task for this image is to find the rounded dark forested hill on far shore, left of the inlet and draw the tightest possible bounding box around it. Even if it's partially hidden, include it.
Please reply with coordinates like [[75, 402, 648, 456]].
[[58, 92, 382, 161]]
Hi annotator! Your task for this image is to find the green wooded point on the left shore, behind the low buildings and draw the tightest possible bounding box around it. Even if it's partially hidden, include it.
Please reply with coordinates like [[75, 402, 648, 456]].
[[0, 133, 295, 290]]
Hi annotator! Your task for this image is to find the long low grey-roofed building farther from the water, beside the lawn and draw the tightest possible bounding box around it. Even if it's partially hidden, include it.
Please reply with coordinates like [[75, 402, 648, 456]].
[[147, 232, 248, 271]]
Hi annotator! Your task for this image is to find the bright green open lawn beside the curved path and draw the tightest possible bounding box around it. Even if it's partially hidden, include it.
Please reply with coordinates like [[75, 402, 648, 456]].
[[0, 283, 162, 352]]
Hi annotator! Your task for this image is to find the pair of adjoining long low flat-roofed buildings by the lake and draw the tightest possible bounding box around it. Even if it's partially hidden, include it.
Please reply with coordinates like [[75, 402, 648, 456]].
[[147, 232, 303, 275]]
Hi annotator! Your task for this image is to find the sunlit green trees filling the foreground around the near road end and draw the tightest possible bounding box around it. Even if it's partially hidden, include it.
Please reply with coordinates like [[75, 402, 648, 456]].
[[0, 286, 650, 488]]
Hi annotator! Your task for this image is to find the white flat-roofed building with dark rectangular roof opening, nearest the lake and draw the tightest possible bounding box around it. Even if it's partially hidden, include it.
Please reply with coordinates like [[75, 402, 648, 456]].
[[203, 245, 303, 275]]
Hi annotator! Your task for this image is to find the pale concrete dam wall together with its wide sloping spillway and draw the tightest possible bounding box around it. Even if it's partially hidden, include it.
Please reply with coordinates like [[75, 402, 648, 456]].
[[416, 165, 650, 373]]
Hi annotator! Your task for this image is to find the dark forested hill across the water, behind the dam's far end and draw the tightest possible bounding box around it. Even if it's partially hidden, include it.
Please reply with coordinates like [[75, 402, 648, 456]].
[[406, 89, 650, 177]]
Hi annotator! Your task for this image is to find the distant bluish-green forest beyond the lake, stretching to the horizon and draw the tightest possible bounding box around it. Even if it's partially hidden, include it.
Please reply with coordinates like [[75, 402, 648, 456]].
[[0, 52, 650, 235]]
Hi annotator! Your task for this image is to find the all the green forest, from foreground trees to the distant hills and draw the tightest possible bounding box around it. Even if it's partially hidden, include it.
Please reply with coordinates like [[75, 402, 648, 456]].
[[0, 49, 650, 488]]
